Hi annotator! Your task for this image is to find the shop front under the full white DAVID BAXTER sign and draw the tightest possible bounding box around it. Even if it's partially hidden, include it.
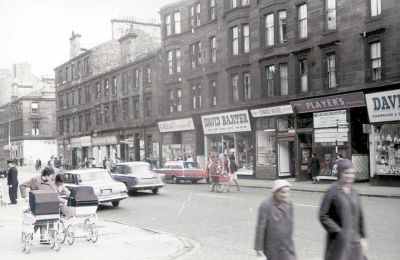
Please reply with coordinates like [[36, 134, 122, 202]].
[[201, 110, 255, 176]]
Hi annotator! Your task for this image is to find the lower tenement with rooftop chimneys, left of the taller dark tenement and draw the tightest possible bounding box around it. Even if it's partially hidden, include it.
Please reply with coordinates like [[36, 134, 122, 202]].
[[55, 18, 160, 168]]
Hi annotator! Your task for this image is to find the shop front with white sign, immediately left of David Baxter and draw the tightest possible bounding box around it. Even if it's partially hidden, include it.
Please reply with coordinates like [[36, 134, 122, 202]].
[[158, 118, 201, 165]]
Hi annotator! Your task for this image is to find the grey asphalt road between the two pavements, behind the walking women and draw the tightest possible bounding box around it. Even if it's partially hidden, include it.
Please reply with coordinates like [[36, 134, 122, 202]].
[[97, 184, 400, 260]]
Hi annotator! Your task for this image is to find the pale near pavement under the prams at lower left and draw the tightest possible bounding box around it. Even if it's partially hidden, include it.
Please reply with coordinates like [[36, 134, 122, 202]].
[[0, 167, 196, 260]]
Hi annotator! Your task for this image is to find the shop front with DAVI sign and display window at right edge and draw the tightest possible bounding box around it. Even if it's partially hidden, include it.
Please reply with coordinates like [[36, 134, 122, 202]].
[[365, 89, 400, 186]]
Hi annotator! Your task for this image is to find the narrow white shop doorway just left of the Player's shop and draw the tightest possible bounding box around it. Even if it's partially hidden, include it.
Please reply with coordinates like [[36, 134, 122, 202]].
[[278, 141, 294, 177]]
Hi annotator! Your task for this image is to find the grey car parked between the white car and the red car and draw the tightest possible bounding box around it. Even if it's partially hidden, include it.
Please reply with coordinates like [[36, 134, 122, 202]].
[[110, 162, 164, 194]]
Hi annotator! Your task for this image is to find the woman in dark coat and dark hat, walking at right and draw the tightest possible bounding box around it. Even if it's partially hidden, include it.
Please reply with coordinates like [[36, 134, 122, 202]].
[[319, 159, 368, 260]]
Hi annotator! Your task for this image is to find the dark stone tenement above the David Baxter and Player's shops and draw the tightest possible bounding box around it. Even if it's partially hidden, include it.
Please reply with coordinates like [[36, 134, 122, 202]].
[[157, 0, 400, 184]]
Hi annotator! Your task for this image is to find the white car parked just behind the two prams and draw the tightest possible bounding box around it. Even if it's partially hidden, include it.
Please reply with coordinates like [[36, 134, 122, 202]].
[[64, 168, 128, 207]]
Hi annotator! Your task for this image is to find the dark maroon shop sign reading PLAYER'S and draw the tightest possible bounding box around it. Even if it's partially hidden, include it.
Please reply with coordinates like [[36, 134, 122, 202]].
[[290, 92, 366, 113]]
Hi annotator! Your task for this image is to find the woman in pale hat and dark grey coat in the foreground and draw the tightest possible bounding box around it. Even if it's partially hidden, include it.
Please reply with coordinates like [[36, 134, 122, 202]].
[[254, 180, 296, 260]]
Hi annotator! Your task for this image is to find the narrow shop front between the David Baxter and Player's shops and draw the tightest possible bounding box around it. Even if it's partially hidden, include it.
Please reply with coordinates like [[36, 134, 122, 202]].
[[250, 105, 295, 179]]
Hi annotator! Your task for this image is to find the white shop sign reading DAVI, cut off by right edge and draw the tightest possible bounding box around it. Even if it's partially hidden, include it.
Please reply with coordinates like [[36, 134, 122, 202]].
[[365, 89, 400, 123]]
